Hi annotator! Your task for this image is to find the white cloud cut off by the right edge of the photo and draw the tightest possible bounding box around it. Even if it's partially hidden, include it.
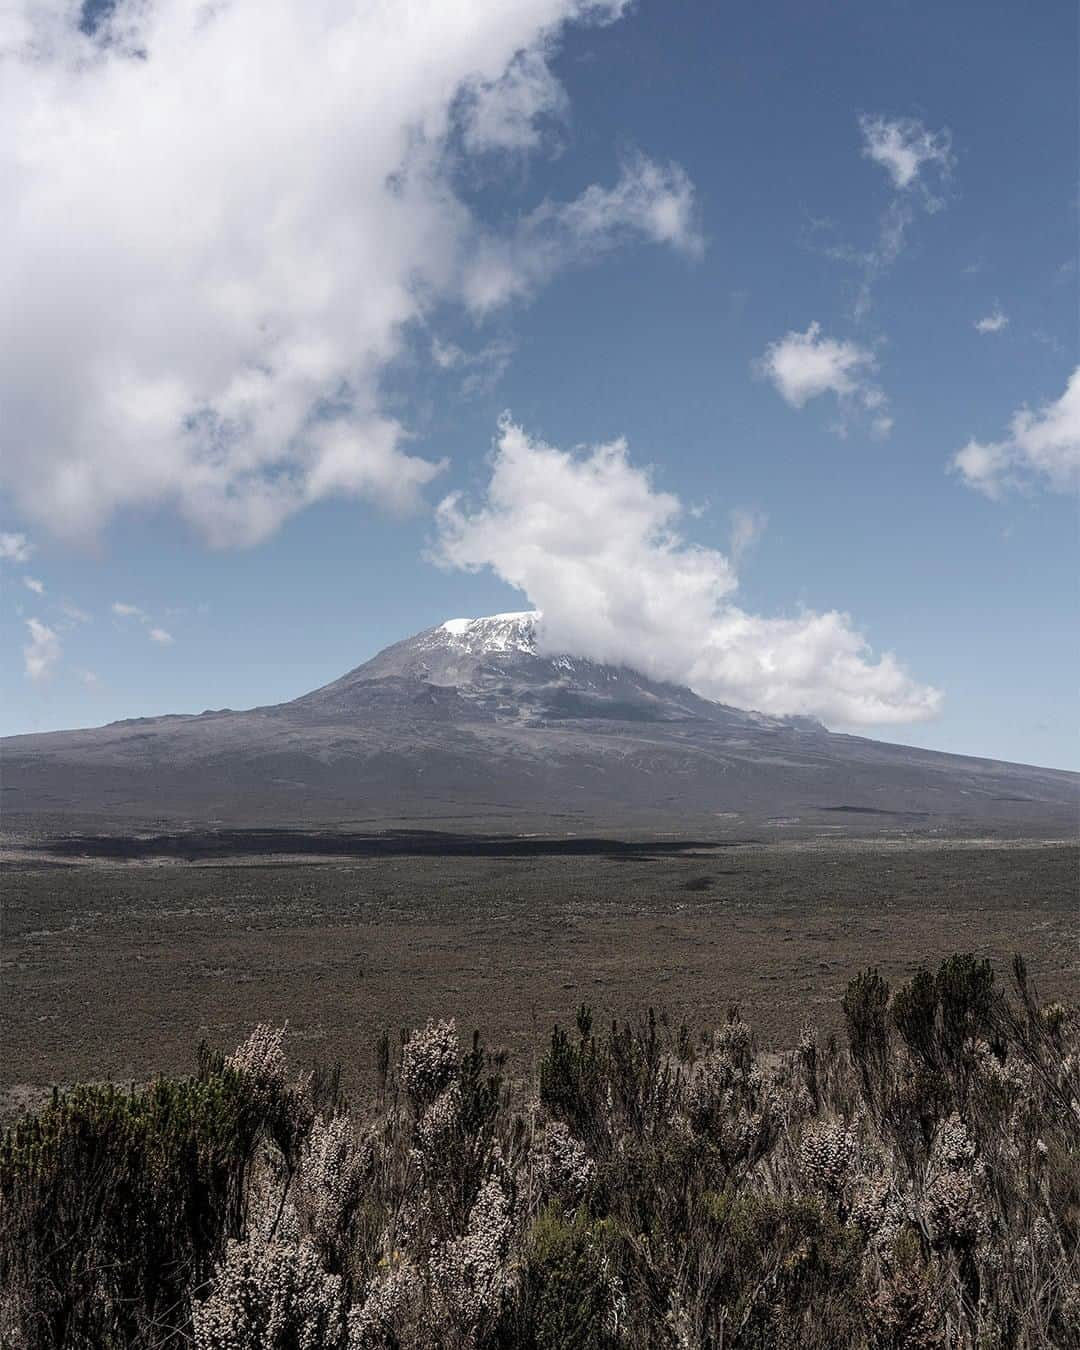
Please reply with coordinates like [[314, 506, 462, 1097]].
[[950, 366, 1080, 500]]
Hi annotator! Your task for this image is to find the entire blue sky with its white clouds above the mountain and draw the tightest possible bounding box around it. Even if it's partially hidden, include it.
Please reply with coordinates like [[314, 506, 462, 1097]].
[[0, 0, 1080, 768]]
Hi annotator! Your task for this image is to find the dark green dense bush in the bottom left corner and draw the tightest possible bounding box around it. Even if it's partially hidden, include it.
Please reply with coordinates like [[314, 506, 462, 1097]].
[[0, 1057, 274, 1347]]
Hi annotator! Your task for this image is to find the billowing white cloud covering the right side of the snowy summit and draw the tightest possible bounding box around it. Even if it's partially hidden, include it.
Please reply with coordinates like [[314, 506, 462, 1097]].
[[432, 419, 941, 725]]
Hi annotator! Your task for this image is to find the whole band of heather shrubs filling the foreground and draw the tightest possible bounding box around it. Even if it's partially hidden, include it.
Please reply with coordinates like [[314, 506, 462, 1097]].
[[0, 954, 1080, 1350]]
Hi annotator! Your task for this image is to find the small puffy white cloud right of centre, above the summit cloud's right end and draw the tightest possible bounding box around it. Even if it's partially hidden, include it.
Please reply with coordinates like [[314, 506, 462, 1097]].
[[755, 323, 892, 435]]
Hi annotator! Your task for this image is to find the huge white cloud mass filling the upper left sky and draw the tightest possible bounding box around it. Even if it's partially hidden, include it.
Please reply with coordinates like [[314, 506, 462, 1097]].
[[0, 0, 699, 545]]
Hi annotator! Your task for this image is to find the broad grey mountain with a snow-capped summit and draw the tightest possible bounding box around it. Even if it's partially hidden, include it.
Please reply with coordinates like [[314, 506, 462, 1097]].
[[0, 613, 1080, 836]]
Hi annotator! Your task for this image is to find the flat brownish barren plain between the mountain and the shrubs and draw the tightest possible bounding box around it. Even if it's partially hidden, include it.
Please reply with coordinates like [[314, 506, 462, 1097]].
[[0, 833, 1080, 1111]]
